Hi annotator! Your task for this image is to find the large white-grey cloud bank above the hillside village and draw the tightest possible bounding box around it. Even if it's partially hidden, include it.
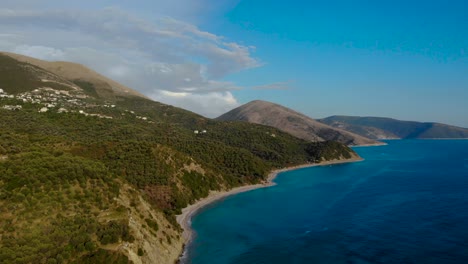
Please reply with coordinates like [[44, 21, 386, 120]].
[[0, 5, 261, 116]]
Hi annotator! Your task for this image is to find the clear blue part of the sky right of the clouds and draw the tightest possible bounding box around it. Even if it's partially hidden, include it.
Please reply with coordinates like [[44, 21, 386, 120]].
[[212, 0, 468, 126]]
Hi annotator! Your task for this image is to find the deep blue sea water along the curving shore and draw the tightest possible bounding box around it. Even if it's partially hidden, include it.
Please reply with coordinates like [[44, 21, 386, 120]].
[[189, 140, 468, 264]]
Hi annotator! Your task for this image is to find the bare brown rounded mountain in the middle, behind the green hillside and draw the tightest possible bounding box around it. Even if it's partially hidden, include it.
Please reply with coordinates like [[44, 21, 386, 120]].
[[216, 100, 381, 145]]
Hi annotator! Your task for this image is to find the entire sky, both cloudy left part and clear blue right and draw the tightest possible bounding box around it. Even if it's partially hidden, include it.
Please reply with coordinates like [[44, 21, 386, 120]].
[[0, 0, 468, 127]]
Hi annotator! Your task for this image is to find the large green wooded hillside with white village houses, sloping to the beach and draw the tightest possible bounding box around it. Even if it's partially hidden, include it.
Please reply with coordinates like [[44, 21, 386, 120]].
[[0, 53, 357, 263]]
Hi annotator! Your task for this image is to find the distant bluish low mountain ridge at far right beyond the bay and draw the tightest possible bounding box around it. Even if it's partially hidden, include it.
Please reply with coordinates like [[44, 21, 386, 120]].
[[319, 116, 468, 139]]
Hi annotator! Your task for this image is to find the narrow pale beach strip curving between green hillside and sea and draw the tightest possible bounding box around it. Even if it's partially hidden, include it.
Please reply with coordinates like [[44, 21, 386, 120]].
[[176, 156, 364, 263]]
